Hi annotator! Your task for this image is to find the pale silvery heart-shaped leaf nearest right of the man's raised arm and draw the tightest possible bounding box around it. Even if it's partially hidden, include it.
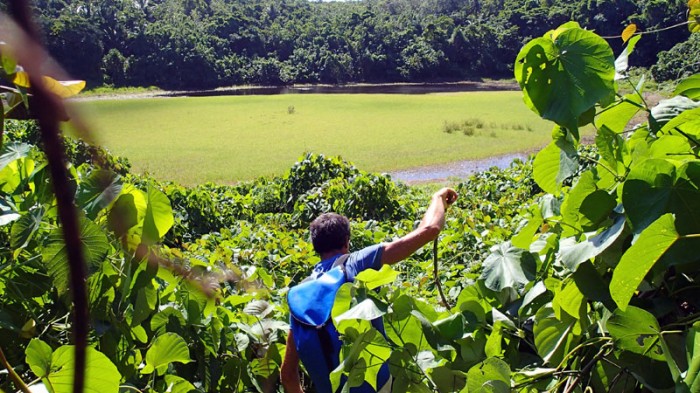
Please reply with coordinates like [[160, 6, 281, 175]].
[[479, 242, 537, 292]]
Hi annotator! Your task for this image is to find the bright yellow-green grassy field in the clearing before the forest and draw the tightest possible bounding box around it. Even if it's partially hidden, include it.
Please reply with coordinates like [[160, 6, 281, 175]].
[[75, 91, 552, 184]]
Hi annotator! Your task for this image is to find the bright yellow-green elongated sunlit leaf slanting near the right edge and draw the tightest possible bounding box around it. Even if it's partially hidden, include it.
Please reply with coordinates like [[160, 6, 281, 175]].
[[610, 214, 679, 310]]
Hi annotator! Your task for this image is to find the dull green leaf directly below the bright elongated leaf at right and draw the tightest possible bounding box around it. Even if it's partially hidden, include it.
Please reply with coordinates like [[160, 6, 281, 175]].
[[606, 306, 664, 361]]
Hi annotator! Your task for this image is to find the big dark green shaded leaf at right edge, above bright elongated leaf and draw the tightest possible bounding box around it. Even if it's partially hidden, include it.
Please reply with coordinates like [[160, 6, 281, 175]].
[[622, 159, 700, 235]]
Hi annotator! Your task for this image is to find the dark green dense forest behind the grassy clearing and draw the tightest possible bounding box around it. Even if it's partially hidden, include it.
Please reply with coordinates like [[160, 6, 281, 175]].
[[13, 0, 698, 89]]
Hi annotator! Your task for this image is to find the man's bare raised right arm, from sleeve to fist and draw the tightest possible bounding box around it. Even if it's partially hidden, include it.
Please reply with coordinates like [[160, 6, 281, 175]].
[[382, 188, 457, 265]]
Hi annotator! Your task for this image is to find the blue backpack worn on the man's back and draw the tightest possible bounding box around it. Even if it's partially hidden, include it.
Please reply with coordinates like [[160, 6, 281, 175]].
[[287, 254, 350, 393]]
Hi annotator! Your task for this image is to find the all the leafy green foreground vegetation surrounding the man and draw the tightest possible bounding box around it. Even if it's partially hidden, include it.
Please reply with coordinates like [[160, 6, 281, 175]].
[[0, 1, 700, 392]]
